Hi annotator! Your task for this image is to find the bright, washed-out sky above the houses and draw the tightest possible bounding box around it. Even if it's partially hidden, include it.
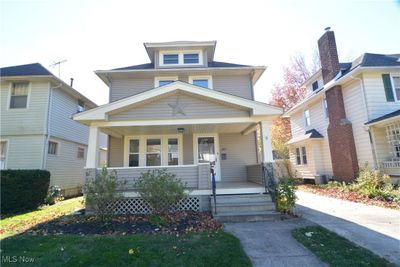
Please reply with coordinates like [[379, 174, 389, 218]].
[[0, 0, 400, 105]]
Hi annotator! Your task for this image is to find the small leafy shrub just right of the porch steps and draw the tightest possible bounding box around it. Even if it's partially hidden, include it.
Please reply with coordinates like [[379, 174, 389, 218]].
[[275, 177, 296, 214]]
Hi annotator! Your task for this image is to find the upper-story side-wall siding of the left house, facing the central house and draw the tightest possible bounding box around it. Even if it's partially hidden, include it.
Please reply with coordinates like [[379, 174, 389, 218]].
[[49, 89, 89, 145]]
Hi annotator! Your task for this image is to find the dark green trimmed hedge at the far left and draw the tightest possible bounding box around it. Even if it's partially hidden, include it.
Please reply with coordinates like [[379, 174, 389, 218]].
[[0, 170, 50, 214]]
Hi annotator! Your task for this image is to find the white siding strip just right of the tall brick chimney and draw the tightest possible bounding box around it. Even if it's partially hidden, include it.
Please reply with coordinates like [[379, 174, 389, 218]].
[[342, 81, 374, 167]]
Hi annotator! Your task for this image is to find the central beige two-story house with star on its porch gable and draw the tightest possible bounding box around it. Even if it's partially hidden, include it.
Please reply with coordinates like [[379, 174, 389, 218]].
[[74, 41, 282, 219]]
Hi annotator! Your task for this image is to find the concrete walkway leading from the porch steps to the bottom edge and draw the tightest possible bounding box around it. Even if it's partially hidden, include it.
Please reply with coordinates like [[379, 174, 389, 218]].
[[225, 219, 327, 267]]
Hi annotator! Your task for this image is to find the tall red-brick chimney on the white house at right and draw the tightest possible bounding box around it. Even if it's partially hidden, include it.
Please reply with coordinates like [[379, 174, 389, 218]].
[[318, 30, 358, 182]]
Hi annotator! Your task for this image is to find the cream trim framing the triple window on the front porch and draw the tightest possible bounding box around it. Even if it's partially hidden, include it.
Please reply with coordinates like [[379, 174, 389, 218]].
[[124, 134, 183, 168]]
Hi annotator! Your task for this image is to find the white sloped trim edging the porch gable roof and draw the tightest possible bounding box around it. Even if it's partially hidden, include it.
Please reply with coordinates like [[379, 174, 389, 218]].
[[73, 81, 282, 122]]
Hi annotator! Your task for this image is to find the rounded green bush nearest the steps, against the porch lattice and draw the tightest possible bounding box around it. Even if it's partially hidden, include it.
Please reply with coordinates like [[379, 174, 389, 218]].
[[135, 169, 186, 214]]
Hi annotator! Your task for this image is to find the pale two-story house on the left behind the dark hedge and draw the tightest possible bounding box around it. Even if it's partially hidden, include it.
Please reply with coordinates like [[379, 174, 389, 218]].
[[0, 63, 104, 196]]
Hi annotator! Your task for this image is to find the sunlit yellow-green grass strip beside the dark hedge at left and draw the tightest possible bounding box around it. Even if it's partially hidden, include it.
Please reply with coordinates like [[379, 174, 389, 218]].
[[0, 197, 83, 239]]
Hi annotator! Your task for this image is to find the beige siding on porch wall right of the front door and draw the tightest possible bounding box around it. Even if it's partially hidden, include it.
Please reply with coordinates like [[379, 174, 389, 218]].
[[219, 133, 257, 182]]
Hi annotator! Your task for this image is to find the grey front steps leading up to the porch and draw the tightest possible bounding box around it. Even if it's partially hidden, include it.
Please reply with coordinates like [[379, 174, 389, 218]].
[[211, 194, 280, 222]]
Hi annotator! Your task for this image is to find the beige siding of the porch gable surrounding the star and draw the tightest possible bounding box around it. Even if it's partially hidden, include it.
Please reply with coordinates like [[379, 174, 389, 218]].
[[109, 94, 249, 120]]
